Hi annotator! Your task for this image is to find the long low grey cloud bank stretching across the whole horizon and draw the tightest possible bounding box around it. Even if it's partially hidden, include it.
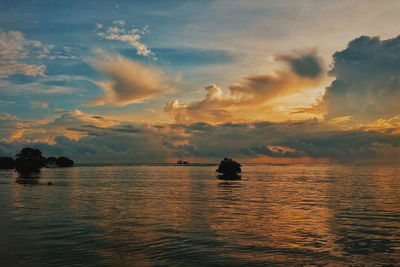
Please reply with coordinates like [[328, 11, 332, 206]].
[[0, 116, 400, 162]]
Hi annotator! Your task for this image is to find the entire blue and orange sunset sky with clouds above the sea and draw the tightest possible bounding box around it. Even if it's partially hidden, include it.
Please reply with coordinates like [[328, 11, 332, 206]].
[[0, 0, 400, 163]]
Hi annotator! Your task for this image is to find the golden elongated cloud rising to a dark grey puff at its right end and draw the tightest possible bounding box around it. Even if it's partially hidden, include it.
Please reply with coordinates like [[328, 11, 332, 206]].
[[165, 51, 323, 123]]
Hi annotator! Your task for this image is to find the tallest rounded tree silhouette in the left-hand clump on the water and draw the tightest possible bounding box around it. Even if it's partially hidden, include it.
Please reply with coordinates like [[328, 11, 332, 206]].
[[15, 147, 46, 178]]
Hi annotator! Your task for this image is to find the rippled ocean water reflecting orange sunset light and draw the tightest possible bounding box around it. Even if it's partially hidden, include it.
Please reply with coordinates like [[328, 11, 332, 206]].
[[0, 164, 400, 266]]
